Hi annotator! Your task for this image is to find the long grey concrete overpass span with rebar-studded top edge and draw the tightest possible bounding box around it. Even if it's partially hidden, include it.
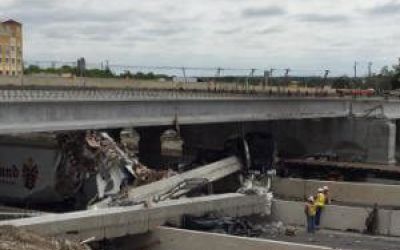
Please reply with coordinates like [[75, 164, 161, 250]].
[[0, 89, 400, 134]]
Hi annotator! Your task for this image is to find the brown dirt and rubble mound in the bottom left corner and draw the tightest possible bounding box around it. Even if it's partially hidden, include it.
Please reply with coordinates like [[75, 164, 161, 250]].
[[0, 226, 90, 250]]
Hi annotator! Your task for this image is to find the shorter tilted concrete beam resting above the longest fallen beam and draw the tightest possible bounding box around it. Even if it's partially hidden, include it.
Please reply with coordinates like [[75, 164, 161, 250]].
[[129, 157, 242, 202]]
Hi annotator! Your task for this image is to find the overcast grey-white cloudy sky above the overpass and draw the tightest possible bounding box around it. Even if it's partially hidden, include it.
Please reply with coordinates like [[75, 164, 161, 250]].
[[0, 0, 400, 74]]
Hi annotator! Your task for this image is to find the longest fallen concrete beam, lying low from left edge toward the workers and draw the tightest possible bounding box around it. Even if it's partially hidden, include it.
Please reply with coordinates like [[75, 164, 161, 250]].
[[0, 194, 267, 240]]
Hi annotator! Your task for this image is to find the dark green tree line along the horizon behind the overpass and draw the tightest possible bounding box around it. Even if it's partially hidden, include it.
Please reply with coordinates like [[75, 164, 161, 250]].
[[24, 65, 400, 91]]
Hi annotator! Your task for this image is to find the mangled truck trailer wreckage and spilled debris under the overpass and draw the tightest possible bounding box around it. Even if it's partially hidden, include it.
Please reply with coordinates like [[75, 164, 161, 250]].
[[56, 131, 174, 206]]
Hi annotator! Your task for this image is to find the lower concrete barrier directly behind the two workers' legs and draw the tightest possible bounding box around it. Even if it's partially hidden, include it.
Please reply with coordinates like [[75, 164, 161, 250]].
[[272, 199, 400, 236]]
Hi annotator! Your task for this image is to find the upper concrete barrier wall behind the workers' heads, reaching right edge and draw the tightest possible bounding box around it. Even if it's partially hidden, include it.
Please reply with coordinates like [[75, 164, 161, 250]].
[[272, 178, 400, 207]]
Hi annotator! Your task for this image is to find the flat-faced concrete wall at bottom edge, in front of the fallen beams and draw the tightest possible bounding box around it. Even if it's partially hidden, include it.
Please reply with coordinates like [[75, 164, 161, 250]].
[[118, 227, 332, 250]]
